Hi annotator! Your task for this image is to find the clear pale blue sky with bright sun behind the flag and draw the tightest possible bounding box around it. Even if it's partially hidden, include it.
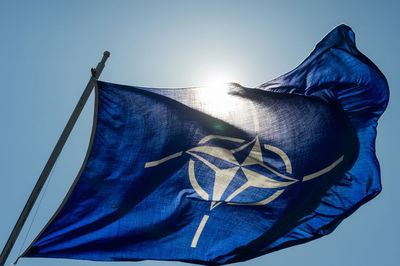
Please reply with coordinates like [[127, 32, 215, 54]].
[[0, 0, 400, 266]]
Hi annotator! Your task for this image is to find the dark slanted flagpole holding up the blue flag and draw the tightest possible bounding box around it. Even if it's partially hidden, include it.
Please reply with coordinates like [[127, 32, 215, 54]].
[[0, 51, 110, 266]]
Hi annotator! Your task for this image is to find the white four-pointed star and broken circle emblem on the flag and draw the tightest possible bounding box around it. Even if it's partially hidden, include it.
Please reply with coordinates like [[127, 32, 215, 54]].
[[186, 135, 297, 210]]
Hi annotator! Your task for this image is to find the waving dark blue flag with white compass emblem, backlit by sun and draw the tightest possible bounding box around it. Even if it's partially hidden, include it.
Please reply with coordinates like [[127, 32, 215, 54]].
[[22, 25, 388, 264]]
